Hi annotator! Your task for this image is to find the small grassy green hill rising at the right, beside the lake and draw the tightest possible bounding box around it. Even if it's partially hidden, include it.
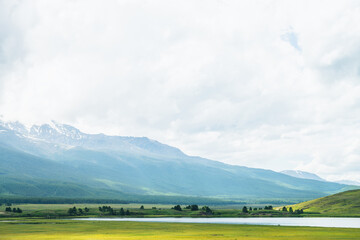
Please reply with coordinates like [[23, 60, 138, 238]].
[[289, 190, 360, 216]]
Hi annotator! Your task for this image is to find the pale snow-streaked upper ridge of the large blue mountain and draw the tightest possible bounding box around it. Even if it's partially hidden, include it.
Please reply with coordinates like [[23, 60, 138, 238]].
[[0, 121, 184, 158]]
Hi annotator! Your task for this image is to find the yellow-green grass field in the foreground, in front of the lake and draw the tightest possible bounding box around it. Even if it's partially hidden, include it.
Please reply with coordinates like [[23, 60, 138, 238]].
[[0, 219, 360, 240]]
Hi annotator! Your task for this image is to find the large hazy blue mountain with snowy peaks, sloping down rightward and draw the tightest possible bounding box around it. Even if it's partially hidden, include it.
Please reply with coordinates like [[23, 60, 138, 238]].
[[0, 121, 351, 200]]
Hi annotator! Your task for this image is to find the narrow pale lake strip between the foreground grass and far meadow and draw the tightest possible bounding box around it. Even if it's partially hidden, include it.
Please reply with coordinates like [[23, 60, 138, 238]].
[[73, 217, 360, 228]]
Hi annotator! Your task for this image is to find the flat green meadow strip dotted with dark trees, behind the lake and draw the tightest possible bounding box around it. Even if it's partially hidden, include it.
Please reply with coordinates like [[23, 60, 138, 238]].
[[0, 204, 306, 220]]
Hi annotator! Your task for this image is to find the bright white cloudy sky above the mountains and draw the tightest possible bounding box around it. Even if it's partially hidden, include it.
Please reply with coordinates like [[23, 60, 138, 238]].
[[0, 0, 360, 181]]
